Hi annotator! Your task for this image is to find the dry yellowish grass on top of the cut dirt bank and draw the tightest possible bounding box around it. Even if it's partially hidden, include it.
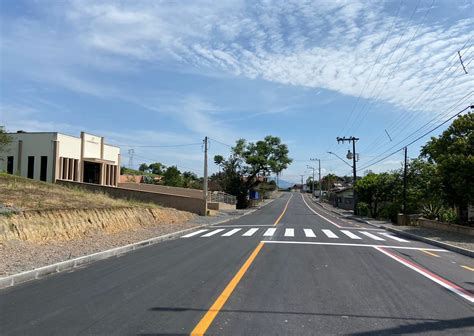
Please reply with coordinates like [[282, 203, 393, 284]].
[[0, 173, 159, 210]]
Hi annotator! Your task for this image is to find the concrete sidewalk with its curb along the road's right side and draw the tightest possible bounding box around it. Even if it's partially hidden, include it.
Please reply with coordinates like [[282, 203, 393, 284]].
[[312, 197, 474, 257]]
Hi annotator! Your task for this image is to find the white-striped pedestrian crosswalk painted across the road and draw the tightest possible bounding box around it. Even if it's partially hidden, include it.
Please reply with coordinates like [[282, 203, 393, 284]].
[[181, 227, 409, 243]]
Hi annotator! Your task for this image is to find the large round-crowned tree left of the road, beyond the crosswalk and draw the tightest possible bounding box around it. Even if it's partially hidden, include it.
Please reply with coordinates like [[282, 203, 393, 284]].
[[214, 136, 292, 208]]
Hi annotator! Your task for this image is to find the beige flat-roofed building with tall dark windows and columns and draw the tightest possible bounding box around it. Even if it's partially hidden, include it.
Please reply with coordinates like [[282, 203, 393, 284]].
[[0, 131, 120, 186]]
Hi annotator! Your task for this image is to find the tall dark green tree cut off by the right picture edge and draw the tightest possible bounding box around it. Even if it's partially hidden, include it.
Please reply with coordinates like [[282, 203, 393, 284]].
[[421, 112, 474, 222]]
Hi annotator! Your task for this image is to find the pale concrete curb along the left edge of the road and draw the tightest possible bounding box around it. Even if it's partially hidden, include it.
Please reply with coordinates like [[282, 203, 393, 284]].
[[0, 199, 275, 289]]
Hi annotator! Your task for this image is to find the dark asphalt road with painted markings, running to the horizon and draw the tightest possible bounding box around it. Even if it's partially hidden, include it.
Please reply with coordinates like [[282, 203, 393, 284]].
[[0, 193, 474, 335]]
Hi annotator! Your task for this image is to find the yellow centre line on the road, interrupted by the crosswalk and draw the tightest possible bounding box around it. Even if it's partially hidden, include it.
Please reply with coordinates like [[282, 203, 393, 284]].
[[191, 194, 293, 336]]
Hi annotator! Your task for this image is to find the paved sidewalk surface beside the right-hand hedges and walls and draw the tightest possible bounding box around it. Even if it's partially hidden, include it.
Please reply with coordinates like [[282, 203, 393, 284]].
[[313, 198, 474, 253]]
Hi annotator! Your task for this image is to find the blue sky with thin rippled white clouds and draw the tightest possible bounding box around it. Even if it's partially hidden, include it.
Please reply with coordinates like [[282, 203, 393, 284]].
[[0, 0, 474, 181]]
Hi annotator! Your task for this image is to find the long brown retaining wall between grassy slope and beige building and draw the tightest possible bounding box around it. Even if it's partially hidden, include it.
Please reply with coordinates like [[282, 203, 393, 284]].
[[56, 180, 206, 216]]
